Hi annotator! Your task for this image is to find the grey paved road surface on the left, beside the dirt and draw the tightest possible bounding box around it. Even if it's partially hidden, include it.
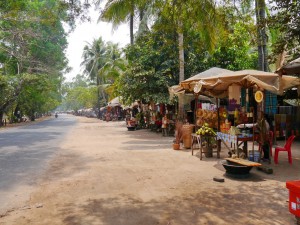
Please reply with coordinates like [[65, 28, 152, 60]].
[[0, 114, 76, 215]]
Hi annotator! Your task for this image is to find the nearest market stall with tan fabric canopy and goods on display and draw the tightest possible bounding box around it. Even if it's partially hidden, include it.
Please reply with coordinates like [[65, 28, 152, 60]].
[[180, 70, 300, 162]]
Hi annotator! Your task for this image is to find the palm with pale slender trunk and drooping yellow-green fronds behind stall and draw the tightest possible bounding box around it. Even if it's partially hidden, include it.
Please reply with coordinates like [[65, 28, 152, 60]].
[[156, 0, 219, 117]]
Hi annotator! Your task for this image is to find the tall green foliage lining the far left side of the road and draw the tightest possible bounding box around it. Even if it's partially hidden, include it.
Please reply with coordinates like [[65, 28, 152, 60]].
[[0, 0, 73, 123]]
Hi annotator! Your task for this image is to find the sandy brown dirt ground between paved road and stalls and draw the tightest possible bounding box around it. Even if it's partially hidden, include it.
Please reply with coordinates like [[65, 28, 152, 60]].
[[0, 117, 300, 225]]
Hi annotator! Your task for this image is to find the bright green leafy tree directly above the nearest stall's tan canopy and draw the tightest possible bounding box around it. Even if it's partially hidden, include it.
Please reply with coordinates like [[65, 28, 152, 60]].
[[202, 5, 258, 70]]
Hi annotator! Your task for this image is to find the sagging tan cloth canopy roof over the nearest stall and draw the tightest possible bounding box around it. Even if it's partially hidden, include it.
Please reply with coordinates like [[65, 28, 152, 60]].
[[180, 70, 300, 98]]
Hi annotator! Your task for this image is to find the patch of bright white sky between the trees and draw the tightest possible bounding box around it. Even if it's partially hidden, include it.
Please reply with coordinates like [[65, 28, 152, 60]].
[[64, 7, 130, 82]]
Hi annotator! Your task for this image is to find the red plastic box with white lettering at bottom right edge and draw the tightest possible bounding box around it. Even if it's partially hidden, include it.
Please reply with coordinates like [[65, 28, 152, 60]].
[[286, 180, 300, 218]]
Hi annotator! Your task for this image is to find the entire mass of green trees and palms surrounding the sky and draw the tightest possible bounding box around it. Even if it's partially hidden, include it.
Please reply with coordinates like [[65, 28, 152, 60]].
[[0, 0, 300, 116]]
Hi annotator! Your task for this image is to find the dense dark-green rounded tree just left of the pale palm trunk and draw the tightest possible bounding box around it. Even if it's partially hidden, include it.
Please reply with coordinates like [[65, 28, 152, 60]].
[[116, 32, 174, 104]]
